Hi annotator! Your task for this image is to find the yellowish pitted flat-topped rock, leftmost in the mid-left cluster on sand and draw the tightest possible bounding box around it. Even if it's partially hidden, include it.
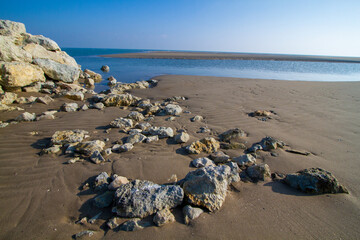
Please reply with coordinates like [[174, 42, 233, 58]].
[[51, 129, 88, 145]]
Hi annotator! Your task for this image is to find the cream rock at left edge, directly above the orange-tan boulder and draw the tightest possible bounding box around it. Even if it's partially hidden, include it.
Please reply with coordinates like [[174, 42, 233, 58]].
[[0, 35, 32, 63]]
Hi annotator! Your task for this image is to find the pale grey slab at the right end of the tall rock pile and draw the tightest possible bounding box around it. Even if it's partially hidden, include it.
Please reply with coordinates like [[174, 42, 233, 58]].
[[33, 58, 80, 83]]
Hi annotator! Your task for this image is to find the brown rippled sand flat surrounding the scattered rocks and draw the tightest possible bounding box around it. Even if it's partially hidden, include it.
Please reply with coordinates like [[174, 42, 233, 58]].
[[0, 76, 360, 239]]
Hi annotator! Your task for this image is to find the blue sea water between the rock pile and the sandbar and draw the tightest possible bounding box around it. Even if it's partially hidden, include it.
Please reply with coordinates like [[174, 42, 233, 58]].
[[62, 48, 360, 91]]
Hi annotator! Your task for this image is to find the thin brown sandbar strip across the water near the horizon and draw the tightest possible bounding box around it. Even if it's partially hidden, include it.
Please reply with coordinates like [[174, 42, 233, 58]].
[[100, 51, 360, 63]]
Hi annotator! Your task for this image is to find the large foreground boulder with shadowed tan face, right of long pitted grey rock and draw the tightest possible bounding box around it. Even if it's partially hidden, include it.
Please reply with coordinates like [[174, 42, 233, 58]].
[[181, 165, 239, 212]]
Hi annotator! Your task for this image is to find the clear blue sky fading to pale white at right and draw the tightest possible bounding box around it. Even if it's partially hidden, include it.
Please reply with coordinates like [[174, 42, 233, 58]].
[[0, 0, 360, 57]]
